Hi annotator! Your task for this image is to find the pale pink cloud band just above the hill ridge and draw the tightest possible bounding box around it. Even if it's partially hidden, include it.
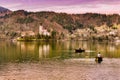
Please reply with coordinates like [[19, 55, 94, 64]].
[[31, 4, 120, 14]]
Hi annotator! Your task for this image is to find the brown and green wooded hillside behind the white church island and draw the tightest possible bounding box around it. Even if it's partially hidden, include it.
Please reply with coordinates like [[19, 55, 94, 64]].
[[0, 10, 120, 40]]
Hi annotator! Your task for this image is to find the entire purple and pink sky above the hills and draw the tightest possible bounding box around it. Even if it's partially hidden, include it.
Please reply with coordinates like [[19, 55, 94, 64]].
[[0, 0, 120, 14]]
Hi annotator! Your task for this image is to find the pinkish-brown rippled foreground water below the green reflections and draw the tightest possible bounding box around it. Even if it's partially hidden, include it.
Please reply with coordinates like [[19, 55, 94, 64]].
[[0, 58, 120, 80]]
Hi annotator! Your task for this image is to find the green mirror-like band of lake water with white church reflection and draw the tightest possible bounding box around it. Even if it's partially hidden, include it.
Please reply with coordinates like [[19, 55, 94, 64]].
[[0, 41, 120, 63]]
